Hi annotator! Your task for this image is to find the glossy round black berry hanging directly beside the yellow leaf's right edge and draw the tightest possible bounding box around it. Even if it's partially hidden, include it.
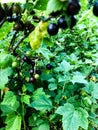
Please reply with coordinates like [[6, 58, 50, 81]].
[[47, 23, 58, 36]]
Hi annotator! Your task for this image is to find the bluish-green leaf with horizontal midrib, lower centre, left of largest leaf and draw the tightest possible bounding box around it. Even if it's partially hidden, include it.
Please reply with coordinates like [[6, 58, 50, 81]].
[[31, 95, 52, 111]]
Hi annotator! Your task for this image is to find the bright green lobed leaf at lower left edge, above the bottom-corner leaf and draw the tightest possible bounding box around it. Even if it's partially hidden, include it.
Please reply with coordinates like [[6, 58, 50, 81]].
[[0, 91, 19, 114]]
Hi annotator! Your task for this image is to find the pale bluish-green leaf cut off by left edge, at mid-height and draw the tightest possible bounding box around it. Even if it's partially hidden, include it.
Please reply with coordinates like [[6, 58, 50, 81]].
[[0, 67, 12, 89]]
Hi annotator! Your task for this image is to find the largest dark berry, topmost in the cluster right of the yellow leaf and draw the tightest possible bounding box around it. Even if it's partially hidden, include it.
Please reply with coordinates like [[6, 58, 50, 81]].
[[67, 0, 81, 15]]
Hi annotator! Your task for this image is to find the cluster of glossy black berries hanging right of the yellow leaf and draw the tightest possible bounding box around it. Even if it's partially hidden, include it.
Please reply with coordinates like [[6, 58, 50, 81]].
[[47, 0, 81, 36]]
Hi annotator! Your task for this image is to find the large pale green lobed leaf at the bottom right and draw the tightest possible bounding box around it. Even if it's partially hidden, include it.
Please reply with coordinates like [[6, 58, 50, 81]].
[[56, 103, 88, 130]]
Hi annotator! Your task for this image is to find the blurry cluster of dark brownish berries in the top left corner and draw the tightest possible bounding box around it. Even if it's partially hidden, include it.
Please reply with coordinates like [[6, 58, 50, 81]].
[[0, 3, 34, 32]]
